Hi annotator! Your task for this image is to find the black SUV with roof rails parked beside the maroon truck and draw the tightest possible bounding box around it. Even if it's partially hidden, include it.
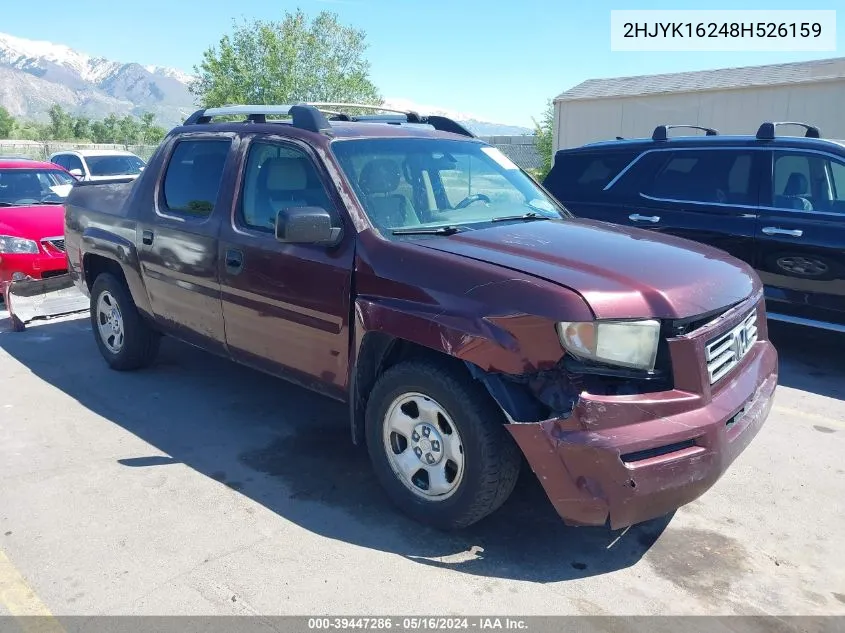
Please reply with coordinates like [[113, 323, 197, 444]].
[[543, 122, 845, 332]]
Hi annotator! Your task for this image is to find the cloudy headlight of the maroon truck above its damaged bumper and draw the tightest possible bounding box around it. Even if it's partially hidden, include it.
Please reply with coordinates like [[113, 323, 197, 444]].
[[557, 320, 660, 370]]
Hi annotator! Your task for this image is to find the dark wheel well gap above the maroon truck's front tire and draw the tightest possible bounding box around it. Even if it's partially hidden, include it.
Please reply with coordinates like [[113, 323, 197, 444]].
[[350, 332, 466, 444]]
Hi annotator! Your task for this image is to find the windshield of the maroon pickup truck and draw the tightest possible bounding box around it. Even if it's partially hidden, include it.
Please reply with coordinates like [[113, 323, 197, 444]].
[[332, 138, 569, 236]]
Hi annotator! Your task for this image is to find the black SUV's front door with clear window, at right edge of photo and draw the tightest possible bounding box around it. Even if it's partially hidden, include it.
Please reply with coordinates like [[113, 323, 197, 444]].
[[755, 149, 845, 325]]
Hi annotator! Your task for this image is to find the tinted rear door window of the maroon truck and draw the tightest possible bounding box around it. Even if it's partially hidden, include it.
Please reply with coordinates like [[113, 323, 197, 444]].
[[164, 139, 231, 217]]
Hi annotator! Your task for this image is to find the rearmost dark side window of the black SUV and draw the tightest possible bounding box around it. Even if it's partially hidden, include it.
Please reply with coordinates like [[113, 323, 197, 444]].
[[543, 152, 639, 200]]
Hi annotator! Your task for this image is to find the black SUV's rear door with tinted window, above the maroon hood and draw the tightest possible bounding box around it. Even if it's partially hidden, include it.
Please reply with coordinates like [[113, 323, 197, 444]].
[[623, 148, 764, 264]]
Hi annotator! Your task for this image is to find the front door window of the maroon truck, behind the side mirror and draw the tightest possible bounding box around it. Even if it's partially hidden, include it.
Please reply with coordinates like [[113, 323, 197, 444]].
[[239, 142, 338, 232]]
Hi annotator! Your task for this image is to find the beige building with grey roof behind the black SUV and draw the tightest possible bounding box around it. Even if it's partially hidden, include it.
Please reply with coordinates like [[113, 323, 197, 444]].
[[554, 57, 845, 150]]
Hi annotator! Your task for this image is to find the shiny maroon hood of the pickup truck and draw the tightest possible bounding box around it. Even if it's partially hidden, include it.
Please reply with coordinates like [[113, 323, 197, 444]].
[[417, 219, 760, 319]]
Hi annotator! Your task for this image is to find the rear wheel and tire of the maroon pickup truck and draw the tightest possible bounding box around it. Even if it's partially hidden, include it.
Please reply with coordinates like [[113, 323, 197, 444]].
[[90, 273, 161, 371]]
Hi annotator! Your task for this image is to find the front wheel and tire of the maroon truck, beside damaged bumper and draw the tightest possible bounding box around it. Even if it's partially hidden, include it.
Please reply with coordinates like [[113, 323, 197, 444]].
[[366, 360, 522, 530]]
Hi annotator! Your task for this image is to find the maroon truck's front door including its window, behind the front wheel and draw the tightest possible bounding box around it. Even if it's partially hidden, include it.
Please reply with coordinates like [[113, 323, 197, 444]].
[[219, 138, 355, 398]]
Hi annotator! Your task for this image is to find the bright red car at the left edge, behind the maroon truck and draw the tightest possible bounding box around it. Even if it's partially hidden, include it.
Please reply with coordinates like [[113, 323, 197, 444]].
[[0, 158, 75, 299]]
